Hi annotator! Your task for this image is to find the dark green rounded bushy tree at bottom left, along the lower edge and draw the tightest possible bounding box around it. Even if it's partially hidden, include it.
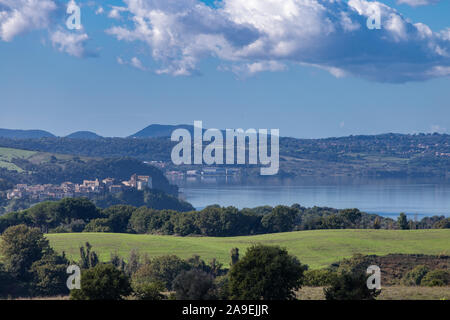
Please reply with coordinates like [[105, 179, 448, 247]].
[[70, 264, 132, 300]]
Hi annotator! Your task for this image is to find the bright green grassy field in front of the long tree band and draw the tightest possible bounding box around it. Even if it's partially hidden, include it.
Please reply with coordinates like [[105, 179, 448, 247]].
[[47, 229, 450, 269]]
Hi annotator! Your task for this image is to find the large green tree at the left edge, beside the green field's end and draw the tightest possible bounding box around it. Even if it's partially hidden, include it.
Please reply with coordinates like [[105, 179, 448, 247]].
[[0, 225, 52, 281]]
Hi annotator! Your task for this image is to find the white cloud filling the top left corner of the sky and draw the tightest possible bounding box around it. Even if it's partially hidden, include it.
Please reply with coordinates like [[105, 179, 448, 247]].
[[0, 0, 58, 41]]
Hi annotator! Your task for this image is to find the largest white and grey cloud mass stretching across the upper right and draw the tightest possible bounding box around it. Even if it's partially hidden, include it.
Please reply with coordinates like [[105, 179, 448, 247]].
[[108, 0, 450, 82]]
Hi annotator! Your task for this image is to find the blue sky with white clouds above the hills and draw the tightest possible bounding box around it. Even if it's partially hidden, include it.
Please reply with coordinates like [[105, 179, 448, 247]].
[[0, 0, 450, 138]]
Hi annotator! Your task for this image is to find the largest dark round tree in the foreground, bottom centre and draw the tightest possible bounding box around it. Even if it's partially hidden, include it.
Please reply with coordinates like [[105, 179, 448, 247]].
[[229, 245, 307, 300]]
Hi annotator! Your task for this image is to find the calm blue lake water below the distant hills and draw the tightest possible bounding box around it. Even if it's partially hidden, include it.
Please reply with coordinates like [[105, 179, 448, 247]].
[[179, 179, 450, 219]]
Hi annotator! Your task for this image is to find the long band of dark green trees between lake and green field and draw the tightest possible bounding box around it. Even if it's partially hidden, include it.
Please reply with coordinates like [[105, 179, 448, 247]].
[[0, 199, 450, 237]]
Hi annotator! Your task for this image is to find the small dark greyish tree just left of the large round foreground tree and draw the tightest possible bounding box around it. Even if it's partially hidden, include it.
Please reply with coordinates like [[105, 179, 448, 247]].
[[173, 269, 216, 300]]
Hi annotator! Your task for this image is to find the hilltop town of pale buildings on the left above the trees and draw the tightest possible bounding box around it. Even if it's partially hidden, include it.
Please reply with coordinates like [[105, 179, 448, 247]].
[[7, 174, 153, 201]]
